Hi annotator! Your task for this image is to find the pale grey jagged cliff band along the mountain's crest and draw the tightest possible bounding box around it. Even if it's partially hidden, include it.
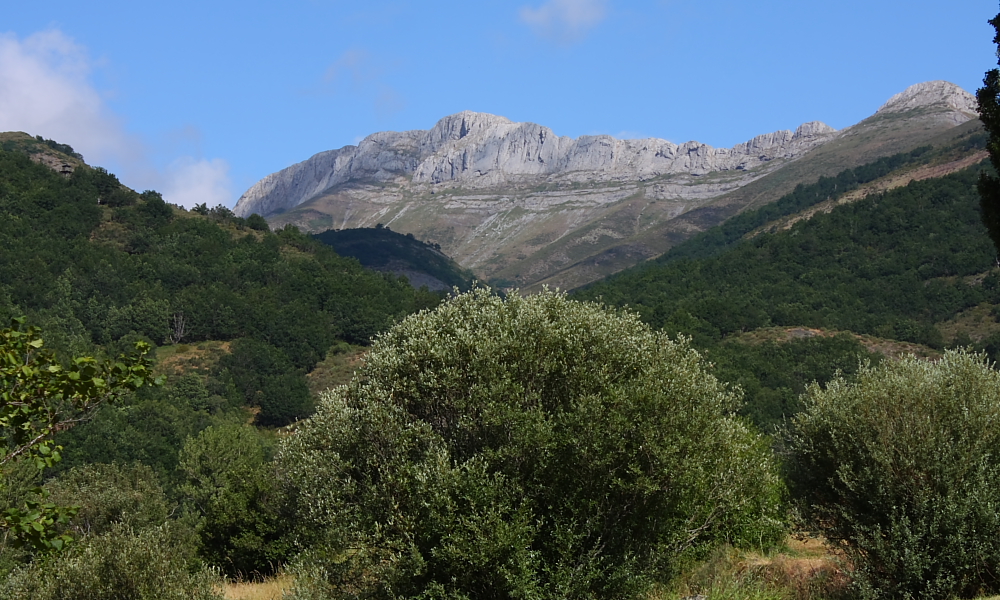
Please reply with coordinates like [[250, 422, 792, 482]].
[[235, 111, 836, 216]]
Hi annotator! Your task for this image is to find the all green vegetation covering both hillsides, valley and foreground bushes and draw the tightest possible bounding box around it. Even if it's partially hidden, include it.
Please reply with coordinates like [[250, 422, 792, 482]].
[[0, 120, 1000, 600]]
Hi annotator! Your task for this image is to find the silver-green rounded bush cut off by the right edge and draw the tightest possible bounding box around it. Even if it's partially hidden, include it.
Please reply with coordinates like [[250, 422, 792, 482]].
[[787, 352, 1000, 598]]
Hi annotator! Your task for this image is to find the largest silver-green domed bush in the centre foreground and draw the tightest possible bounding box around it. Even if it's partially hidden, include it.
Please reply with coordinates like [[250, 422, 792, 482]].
[[279, 289, 784, 599]]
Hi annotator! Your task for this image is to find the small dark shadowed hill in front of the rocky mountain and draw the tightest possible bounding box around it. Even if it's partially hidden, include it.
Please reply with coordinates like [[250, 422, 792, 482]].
[[313, 224, 473, 291]]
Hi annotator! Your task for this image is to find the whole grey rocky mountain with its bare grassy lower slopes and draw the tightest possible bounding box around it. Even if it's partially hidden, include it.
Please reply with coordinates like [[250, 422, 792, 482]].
[[234, 81, 978, 289]]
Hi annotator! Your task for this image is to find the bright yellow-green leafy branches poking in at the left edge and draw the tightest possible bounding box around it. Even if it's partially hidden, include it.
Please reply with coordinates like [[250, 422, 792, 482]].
[[0, 317, 163, 550]]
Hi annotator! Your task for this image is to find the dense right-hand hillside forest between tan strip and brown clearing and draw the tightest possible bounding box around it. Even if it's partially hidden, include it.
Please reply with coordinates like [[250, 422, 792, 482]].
[[577, 162, 1000, 347]]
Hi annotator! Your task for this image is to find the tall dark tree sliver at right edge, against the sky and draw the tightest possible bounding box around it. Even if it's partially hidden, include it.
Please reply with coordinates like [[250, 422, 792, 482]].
[[976, 9, 1000, 251]]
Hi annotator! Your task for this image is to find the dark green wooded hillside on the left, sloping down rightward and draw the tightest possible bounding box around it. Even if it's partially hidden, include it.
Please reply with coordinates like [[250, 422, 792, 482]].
[[0, 146, 440, 425]]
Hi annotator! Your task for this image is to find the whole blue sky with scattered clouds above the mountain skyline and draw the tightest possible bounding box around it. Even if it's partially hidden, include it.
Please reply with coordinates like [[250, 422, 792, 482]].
[[0, 0, 1000, 206]]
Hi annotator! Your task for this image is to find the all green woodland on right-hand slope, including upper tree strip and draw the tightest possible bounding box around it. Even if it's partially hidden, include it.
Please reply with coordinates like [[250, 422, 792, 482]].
[[573, 148, 1000, 430]]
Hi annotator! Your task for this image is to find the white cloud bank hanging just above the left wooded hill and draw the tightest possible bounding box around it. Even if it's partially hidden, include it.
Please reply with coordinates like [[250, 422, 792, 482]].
[[0, 30, 233, 207]]
